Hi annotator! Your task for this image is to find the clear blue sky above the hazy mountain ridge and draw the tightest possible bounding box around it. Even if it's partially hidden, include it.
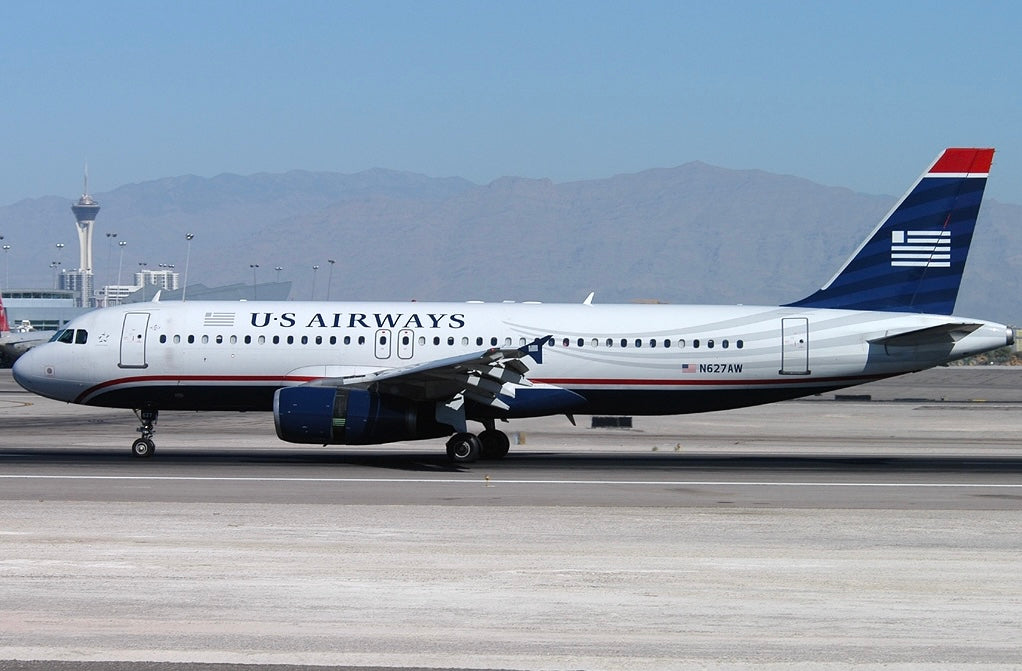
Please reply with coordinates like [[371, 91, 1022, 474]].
[[0, 0, 1022, 204]]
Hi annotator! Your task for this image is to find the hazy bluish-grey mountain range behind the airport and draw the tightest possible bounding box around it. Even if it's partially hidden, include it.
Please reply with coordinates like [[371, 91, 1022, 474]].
[[0, 162, 1022, 324]]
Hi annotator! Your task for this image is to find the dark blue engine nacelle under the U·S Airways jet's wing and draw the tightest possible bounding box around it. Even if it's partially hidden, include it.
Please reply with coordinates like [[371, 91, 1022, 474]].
[[273, 386, 453, 445]]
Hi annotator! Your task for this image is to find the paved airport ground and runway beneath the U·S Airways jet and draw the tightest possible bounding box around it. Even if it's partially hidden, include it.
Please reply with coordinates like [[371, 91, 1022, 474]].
[[0, 369, 1022, 669]]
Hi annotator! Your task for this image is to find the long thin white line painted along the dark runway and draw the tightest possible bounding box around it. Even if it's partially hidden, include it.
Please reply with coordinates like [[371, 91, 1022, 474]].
[[0, 474, 1022, 489]]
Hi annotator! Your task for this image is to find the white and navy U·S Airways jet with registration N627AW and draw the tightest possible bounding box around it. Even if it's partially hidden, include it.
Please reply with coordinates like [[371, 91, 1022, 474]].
[[13, 148, 1014, 464]]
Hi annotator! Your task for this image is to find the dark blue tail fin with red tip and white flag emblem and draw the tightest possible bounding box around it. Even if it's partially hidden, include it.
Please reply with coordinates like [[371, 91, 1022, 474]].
[[790, 149, 993, 315]]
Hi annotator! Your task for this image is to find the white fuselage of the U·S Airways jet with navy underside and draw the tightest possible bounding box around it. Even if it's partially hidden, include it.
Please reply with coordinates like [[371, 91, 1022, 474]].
[[15, 301, 1011, 419]]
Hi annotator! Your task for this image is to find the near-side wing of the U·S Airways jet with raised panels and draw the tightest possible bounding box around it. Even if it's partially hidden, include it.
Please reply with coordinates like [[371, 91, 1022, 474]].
[[309, 336, 553, 410]]
